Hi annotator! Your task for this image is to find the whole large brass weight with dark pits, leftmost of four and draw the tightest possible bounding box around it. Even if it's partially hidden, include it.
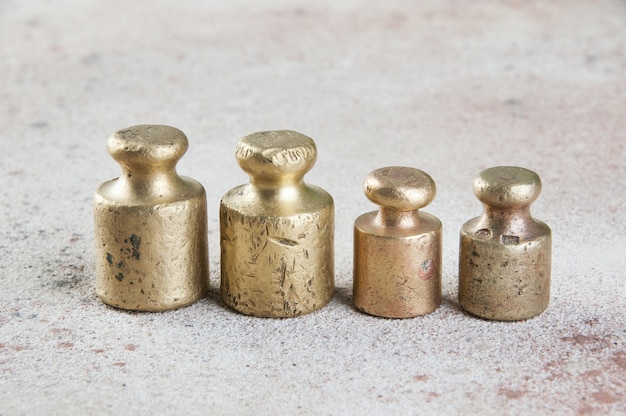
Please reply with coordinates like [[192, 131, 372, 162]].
[[94, 125, 209, 311]]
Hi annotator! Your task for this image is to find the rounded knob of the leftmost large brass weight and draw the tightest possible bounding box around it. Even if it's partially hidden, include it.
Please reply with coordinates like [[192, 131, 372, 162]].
[[107, 125, 189, 169]]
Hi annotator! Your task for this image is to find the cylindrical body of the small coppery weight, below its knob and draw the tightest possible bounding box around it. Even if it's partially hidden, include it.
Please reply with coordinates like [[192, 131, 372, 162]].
[[353, 212, 441, 318]]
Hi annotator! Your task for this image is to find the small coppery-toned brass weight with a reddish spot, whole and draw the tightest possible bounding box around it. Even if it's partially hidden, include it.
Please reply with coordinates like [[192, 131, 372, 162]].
[[353, 166, 442, 318]]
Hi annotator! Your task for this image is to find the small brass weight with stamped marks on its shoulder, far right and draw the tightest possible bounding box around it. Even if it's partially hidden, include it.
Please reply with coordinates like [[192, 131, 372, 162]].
[[459, 166, 552, 321]]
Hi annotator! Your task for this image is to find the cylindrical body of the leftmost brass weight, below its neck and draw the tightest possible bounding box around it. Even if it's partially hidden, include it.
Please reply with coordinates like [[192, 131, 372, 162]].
[[95, 192, 208, 311]]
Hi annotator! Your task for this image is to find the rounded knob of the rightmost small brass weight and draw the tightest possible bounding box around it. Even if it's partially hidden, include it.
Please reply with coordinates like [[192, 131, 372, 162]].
[[474, 166, 541, 209]]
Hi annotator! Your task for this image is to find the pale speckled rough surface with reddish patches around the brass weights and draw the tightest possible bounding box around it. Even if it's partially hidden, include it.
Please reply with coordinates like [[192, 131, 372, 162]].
[[0, 0, 626, 416]]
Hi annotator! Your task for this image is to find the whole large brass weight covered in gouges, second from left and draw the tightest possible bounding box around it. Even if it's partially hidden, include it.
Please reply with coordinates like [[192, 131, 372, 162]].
[[220, 130, 334, 318]]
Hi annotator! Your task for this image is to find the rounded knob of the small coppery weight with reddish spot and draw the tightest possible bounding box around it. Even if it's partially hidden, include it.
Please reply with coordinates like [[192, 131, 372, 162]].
[[363, 166, 436, 211]]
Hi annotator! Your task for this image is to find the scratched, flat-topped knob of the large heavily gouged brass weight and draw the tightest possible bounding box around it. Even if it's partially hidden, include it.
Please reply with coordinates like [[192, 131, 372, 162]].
[[235, 130, 317, 185]]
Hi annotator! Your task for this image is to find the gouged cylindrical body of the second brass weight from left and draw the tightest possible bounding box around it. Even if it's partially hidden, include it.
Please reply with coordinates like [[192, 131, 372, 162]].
[[220, 185, 334, 317]]
